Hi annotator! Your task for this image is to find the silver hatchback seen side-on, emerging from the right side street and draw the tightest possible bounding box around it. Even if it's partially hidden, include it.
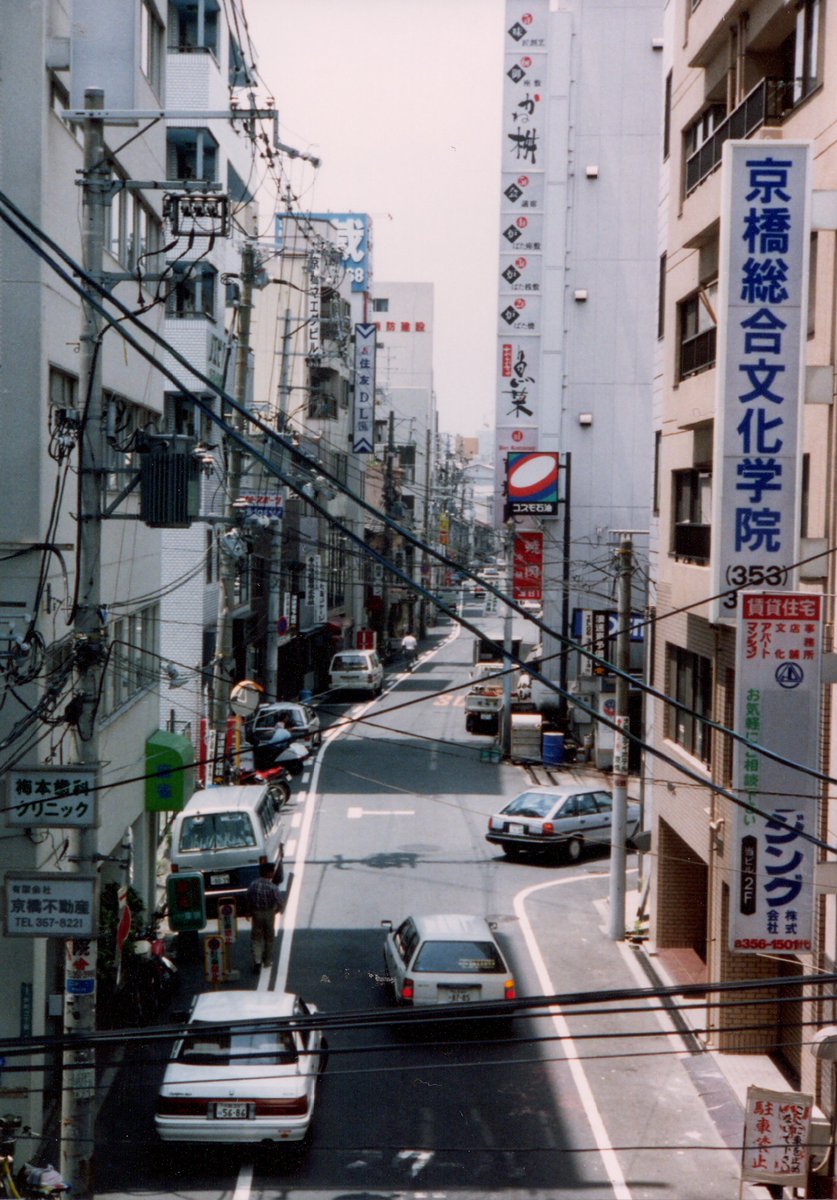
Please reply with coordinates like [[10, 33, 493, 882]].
[[486, 784, 639, 862]]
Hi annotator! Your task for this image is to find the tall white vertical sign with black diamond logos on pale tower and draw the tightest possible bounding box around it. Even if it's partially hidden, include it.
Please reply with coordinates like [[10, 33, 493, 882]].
[[495, 0, 549, 521]]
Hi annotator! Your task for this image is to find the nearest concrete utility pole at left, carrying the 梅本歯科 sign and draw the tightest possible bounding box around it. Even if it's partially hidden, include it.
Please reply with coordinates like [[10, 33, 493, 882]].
[[60, 88, 110, 1200]]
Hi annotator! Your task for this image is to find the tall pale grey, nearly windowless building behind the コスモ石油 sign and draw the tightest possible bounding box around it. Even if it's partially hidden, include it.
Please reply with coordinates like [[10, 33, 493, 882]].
[[495, 0, 663, 733]]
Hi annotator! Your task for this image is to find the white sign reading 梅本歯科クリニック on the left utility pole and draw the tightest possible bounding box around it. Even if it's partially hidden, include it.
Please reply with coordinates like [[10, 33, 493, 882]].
[[6, 764, 97, 829]]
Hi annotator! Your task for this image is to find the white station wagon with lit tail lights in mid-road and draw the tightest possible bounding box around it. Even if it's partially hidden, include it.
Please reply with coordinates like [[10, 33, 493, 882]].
[[381, 913, 514, 1004]]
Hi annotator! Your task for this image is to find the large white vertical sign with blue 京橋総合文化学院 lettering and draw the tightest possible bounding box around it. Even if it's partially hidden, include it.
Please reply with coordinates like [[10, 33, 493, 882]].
[[711, 142, 811, 620]]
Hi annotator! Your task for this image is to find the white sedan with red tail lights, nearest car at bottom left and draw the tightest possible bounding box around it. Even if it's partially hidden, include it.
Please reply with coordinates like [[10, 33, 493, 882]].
[[155, 991, 326, 1142]]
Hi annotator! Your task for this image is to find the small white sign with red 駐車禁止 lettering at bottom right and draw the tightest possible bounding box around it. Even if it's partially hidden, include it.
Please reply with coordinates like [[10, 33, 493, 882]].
[[741, 1087, 813, 1188]]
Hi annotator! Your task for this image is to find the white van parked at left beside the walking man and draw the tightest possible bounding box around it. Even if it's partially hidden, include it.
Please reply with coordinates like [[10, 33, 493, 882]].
[[170, 784, 284, 916]]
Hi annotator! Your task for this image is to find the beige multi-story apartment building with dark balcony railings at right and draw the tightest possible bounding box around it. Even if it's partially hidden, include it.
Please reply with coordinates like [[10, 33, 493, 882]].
[[648, 0, 837, 1109]]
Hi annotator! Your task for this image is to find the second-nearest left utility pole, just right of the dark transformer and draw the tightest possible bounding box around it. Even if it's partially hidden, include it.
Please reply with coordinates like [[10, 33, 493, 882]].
[[212, 240, 255, 754]]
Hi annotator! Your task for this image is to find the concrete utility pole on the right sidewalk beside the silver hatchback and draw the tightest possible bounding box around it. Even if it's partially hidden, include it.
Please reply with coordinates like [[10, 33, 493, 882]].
[[609, 533, 633, 942]]
